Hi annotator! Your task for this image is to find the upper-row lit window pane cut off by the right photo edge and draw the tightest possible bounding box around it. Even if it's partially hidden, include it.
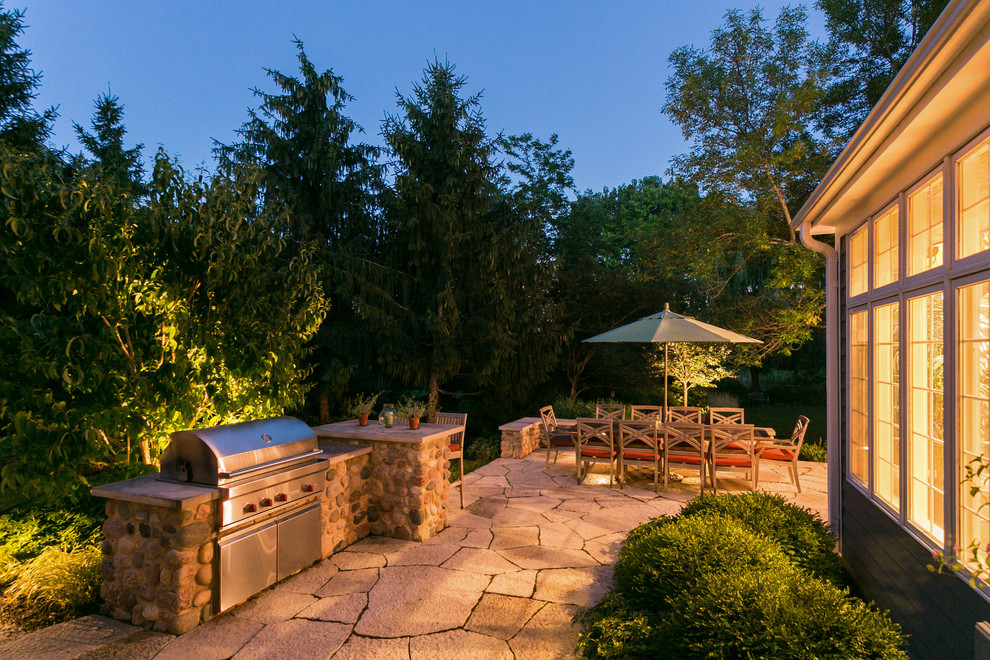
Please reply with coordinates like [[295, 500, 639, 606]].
[[956, 138, 990, 258]]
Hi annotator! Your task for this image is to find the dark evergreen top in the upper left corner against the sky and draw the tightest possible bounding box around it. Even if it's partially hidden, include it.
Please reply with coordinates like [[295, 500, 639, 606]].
[[0, 0, 57, 151]]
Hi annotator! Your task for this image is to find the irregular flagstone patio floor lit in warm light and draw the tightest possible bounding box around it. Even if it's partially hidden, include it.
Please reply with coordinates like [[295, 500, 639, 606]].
[[0, 452, 827, 660]]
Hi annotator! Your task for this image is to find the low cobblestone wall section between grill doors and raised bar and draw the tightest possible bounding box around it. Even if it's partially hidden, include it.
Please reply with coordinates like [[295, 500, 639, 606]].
[[322, 454, 372, 558]]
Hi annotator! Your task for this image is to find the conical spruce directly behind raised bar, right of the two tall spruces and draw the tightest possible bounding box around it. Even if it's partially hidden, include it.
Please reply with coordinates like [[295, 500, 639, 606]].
[[378, 61, 542, 419]]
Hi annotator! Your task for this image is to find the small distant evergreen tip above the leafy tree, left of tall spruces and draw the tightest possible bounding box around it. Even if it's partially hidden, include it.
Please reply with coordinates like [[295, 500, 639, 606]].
[[72, 92, 144, 198]]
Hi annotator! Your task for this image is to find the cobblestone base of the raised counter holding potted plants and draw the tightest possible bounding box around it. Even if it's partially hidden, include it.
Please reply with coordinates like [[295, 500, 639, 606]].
[[333, 438, 450, 541]]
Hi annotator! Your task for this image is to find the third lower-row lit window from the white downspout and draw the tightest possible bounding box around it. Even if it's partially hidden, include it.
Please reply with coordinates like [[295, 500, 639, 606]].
[[907, 292, 945, 541]]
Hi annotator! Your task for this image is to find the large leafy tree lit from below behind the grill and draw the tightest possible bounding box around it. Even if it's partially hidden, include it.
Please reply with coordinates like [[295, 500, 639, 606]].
[[0, 147, 324, 501]]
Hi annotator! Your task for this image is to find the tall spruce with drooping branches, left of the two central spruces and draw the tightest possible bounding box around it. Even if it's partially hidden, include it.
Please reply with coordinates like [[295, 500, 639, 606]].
[[214, 40, 381, 421]]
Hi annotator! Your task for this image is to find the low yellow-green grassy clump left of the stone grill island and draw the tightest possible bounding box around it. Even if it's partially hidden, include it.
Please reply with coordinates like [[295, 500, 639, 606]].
[[0, 546, 102, 626]]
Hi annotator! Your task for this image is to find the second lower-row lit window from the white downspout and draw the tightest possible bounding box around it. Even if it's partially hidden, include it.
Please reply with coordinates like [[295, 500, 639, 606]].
[[873, 303, 901, 509]]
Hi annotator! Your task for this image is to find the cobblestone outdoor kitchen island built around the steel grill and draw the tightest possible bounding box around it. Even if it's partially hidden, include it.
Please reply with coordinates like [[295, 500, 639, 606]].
[[93, 418, 458, 634]]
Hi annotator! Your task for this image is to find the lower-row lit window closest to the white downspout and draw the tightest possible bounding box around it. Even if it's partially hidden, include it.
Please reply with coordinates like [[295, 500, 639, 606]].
[[849, 311, 870, 486]]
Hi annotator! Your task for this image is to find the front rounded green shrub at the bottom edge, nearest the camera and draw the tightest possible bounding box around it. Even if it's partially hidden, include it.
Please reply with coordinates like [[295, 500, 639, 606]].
[[579, 496, 907, 659]]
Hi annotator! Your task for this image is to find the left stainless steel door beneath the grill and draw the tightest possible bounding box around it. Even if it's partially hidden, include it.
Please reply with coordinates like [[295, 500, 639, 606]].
[[217, 522, 278, 612]]
